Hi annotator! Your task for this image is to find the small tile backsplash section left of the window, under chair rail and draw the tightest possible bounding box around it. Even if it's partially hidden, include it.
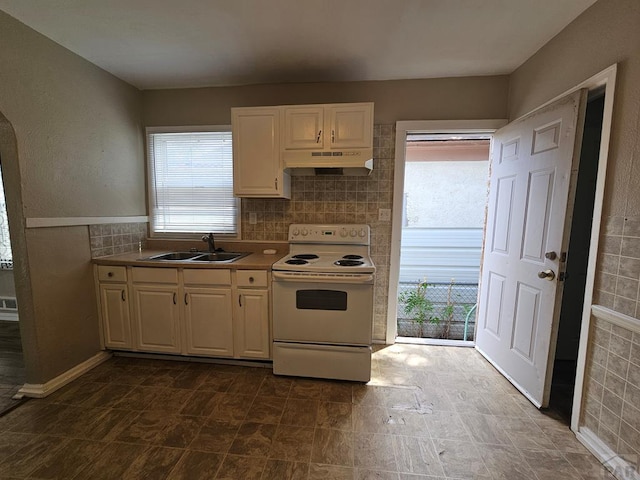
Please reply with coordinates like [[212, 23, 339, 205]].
[[89, 222, 147, 258]]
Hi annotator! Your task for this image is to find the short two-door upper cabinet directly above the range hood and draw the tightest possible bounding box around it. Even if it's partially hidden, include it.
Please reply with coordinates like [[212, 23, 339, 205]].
[[282, 103, 373, 150]]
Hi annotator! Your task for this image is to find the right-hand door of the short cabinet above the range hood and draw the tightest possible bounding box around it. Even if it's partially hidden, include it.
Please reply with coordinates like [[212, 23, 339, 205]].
[[328, 104, 373, 149]]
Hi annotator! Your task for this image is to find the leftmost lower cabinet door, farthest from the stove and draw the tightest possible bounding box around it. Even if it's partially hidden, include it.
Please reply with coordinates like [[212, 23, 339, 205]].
[[100, 283, 133, 349]]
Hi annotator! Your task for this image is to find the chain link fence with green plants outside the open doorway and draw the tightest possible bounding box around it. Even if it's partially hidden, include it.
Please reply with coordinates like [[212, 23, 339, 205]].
[[397, 282, 478, 340]]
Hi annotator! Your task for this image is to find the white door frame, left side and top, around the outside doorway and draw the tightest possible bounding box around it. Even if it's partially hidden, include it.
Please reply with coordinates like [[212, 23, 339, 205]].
[[386, 118, 508, 345]]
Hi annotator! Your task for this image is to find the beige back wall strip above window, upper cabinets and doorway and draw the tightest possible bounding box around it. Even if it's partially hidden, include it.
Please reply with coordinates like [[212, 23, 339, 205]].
[[143, 76, 508, 126]]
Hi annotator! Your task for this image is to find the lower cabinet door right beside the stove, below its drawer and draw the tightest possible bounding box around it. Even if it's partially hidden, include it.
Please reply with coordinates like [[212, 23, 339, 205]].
[[234, 288, 271, 358]]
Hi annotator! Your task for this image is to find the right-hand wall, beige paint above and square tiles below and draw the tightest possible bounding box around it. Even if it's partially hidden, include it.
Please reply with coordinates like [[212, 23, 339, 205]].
[[509, 0, 640, 464]]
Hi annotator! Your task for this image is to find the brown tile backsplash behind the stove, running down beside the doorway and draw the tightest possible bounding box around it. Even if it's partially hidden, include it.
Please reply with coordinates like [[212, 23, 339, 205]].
[[242, 125, 395, 340]]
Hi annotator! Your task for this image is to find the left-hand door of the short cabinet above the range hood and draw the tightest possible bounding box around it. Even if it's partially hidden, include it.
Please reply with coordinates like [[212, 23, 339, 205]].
[[283, 106, 325, 150]]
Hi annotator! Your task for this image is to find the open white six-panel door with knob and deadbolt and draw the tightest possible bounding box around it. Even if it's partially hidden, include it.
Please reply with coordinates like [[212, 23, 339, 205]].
[[476, 90, 586, 407]]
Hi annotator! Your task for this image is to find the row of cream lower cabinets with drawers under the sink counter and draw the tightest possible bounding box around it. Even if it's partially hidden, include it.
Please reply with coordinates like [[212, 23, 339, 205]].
[[96, 266, 271, 359]]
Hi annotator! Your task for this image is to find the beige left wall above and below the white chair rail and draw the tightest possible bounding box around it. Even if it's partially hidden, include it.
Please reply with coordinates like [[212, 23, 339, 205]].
[[0, 12, 145, 383]]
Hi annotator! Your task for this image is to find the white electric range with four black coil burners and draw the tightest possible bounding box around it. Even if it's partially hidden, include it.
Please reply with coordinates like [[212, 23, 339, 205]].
[[272, 224, 376, 382]]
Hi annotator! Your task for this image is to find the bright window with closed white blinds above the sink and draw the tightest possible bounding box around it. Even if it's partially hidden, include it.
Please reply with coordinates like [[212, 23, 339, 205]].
[[147, 127, 240, 236]]
